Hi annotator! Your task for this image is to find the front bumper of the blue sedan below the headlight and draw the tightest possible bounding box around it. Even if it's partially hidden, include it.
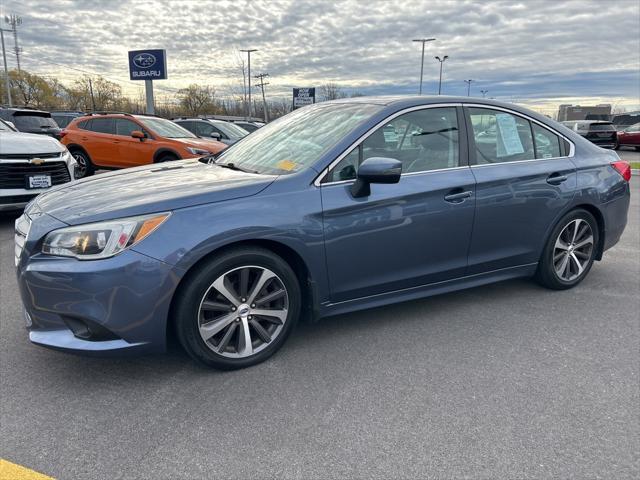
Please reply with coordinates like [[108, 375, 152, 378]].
[[17, 242, 179, 356]]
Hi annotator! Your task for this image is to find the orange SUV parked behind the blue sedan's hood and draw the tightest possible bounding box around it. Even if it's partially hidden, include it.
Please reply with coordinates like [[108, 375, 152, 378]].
[[61, 113, 226, 178]]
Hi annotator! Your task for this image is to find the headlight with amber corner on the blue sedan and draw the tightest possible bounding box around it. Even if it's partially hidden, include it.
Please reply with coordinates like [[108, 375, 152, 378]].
[[42, 213, 170, 260]]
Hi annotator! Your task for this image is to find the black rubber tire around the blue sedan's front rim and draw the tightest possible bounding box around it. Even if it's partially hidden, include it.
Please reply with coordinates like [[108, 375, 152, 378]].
[[173, 247, 301, 370]]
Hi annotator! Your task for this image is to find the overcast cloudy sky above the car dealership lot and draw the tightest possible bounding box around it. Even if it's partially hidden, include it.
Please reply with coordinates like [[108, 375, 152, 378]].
[[0, 0, 640, 112]]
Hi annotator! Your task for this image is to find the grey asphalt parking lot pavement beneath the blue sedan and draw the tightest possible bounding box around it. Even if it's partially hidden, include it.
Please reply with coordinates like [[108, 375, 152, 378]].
[[0, 150, 640, 479]]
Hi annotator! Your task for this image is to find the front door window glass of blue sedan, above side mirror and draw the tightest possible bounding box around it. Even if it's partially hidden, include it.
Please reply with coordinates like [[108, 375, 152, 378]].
[[323, 107, 459, 183]]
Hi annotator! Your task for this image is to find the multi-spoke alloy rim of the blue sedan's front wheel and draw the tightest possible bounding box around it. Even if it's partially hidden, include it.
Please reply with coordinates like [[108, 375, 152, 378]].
[[198, 265, 289, 358]]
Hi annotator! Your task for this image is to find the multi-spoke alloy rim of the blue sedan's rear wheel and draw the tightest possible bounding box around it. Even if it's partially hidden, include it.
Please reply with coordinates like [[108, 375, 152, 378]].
[[553, 218, 594, 282]]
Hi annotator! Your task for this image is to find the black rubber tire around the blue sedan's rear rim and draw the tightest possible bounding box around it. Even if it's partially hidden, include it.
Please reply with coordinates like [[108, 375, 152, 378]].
[[538, 209, 600, 290]]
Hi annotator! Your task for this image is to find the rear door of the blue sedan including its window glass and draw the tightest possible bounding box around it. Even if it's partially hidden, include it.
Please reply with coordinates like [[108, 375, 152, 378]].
[[465, 105, 576, 275]]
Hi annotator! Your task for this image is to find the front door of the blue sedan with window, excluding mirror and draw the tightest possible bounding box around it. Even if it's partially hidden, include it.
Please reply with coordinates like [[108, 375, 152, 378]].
[[320, 107, 475, 302]]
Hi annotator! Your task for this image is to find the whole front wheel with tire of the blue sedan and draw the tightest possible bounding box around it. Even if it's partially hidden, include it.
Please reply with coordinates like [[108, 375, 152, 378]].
[[173, 247, 301, 370]]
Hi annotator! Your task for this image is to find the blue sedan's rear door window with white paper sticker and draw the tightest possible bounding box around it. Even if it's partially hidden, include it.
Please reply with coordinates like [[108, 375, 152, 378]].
[[468, 108, 535, 165]]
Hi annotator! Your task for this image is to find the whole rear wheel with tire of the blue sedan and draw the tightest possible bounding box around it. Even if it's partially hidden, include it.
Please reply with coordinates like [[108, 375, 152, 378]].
[[536, 209, 600, 290]]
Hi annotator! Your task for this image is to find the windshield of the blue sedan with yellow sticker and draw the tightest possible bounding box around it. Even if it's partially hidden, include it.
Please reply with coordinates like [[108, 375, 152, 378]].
[[218, 103, 382, 175]]
